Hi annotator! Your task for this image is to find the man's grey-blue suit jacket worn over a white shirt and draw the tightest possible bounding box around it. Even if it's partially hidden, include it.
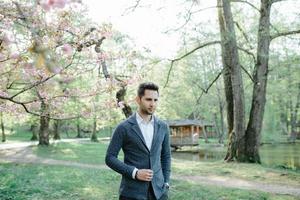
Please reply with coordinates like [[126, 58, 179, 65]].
[[105, 114, 171, 200]]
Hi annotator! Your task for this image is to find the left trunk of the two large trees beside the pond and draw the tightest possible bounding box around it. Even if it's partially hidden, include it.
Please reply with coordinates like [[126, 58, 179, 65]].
[[218, 0, 246, 162]]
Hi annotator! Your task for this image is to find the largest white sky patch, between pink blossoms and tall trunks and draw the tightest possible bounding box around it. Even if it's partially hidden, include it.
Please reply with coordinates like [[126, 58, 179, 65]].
[[83, 0, 197, 58]]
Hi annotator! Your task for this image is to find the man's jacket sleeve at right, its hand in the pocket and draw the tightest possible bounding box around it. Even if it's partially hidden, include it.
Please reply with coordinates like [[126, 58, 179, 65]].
[[161, 124, 171, 183]]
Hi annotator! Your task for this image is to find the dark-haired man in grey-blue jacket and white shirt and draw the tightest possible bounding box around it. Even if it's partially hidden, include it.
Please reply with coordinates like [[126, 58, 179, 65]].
[[105, 83, 171, 200]]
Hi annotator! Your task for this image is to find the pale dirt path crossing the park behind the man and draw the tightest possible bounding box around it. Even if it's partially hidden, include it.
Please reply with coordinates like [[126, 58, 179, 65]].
[[0, 142, 300, 197]]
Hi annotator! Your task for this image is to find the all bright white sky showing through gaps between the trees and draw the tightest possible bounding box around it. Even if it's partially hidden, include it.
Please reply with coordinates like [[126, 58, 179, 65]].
[[82, 0, 300, 58]]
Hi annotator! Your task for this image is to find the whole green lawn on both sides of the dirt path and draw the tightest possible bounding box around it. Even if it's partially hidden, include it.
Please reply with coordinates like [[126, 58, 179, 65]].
[[0, 141, 300, 200]]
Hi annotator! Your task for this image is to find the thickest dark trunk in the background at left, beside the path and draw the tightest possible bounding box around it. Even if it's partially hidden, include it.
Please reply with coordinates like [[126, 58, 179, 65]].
[[39, 100, 50, 146]]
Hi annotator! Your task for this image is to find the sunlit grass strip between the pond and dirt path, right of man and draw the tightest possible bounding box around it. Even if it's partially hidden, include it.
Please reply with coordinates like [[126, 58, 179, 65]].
[[172, 160, 300, 188]]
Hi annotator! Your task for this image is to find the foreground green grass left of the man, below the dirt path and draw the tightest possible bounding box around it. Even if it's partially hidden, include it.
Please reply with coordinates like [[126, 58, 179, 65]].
[[0, 164, 119, 200]]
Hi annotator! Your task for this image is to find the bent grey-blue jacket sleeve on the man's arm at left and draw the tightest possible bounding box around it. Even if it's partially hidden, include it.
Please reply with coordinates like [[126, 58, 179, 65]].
[[105, 124, 135, 178]]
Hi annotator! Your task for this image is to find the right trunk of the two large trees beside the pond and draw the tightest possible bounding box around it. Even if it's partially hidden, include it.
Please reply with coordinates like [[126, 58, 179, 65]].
[[246, 0, 272, 163]]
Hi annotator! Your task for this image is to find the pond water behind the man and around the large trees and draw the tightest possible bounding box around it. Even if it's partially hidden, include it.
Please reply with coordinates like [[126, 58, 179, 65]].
[[172, 143, 300, 170]]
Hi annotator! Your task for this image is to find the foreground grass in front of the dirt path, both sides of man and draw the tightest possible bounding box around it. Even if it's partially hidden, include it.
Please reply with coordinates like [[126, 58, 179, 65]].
[[0, 164, 295, 200]]
